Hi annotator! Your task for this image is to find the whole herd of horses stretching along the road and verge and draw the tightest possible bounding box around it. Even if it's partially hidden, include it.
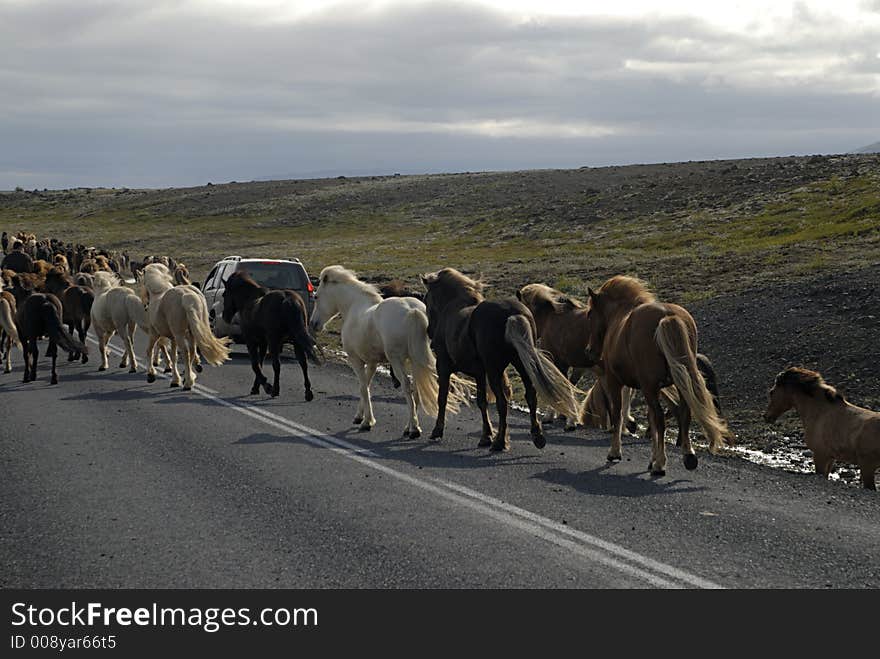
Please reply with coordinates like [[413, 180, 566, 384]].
[[0, 233, 880, 489]]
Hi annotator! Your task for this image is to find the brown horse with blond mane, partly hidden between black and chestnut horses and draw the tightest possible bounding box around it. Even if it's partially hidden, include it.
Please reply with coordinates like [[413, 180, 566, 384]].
[[516, 284, 637, 433]]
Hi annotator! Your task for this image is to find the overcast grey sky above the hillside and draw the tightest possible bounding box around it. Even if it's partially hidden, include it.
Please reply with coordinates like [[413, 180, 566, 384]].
[[0, 0, 880, 189]]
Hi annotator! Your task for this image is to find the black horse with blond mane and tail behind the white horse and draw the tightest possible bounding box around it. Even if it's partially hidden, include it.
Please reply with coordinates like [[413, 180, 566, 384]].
[[422, 268, 577, 451]]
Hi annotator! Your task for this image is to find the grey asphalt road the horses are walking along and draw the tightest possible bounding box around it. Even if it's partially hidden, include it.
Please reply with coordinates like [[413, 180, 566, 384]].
[[0, 337, 880, 588]]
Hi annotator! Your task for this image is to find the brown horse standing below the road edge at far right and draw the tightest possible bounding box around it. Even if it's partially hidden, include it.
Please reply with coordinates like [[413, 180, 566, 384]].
[[764, 368, 880, 490]]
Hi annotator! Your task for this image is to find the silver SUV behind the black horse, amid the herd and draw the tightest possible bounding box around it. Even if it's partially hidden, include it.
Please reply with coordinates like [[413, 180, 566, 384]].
[[202, 256, 315, 341]]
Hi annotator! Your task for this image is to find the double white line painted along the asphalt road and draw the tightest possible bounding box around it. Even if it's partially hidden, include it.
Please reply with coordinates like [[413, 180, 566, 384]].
[[89, 337, 723, 589]]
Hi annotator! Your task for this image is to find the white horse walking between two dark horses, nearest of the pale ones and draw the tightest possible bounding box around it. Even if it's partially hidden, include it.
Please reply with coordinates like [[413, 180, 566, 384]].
[[311, 265, 467, 439]]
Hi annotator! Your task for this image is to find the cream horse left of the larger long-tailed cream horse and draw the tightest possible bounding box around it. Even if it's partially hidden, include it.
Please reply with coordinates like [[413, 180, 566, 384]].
[[92, 271, 150, 373]]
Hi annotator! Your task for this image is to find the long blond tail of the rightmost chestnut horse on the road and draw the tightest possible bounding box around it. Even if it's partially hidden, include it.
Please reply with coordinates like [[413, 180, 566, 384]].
[[654, 316, 732, 453]]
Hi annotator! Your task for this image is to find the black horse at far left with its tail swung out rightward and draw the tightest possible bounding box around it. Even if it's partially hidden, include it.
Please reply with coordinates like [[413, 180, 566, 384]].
[[15, 293, 88, 384]]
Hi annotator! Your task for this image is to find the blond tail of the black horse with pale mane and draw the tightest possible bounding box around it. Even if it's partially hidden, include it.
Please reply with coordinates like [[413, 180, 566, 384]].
[[504, 314, 579, 419]]
